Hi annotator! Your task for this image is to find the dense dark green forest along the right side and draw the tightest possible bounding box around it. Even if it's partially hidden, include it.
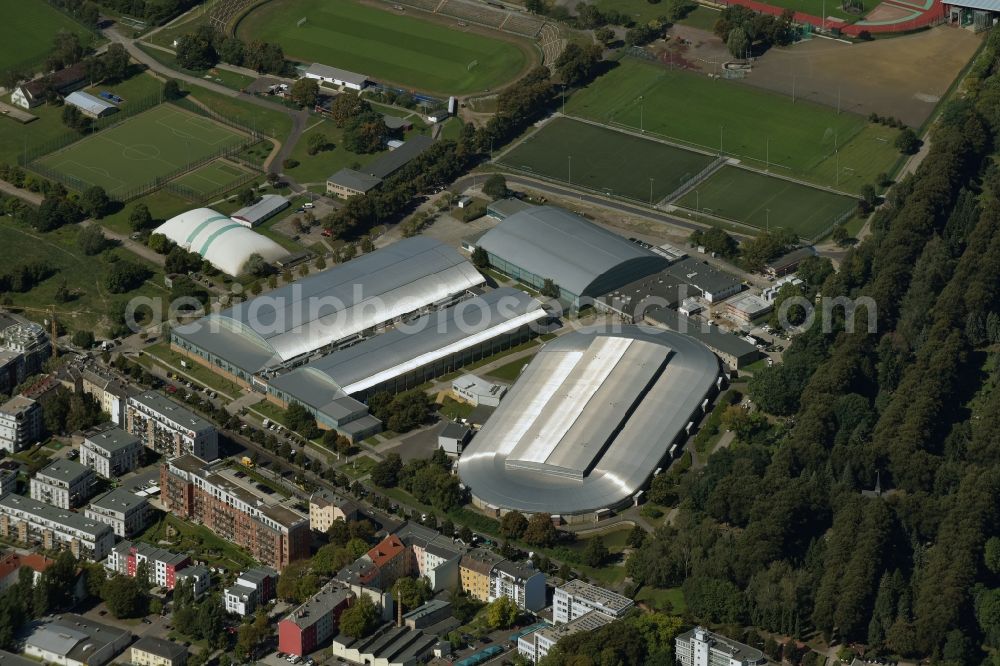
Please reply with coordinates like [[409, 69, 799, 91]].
[[627, 31, 1000, 664]]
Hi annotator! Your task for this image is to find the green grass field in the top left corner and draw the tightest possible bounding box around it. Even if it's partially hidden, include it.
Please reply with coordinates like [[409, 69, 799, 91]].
[[0, 0, 94, 71]]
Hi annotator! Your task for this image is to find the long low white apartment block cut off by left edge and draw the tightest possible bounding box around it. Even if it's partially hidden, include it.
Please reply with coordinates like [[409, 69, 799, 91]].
[[0, 494, 115, 562]]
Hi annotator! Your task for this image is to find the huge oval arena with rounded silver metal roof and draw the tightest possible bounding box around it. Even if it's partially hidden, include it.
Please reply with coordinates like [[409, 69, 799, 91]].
[[458, 325, 719, 522]]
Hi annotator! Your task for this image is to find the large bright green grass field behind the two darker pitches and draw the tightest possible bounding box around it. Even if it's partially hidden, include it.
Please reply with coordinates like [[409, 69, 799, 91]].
[[566, 58, 898, 187]]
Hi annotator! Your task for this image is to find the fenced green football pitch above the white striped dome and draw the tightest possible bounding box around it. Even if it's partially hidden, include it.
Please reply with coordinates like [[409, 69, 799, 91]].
[[31, 104, 247, 196]]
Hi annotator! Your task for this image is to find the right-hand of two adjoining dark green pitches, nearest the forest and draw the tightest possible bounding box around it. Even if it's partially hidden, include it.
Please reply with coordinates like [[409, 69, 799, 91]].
[[674, 166, 857, 238]]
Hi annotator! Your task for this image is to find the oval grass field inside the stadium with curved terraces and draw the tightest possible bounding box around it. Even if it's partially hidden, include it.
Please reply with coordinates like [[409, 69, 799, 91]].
[[238, 0, 533, 95]]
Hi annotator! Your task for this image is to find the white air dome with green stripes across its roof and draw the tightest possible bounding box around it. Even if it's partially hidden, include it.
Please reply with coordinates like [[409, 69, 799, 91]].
[[153, 208, 288, 275]]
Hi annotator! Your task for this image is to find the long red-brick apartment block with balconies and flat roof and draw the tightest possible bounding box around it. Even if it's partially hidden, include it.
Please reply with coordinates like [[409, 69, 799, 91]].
[[160, 454, 312, 569]]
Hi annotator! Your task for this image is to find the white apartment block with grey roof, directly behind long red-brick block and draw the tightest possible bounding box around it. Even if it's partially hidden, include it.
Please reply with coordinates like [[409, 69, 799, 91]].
[[125, 391, 219, 462]]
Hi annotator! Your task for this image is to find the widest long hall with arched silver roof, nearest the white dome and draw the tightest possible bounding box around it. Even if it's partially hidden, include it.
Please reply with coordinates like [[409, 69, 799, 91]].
[[170, 236, 485, 391]]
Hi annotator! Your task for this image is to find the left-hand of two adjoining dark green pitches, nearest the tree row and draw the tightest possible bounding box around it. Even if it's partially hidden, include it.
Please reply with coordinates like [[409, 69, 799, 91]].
[[499, 118, 713, 203]]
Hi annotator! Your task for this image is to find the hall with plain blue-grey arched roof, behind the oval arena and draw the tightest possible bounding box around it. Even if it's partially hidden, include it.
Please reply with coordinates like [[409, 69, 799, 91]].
[[477, 206, 670, 305]]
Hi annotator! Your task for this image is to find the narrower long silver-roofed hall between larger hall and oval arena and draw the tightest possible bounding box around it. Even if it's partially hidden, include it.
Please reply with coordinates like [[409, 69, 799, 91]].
[[267, 288, 549, 438]]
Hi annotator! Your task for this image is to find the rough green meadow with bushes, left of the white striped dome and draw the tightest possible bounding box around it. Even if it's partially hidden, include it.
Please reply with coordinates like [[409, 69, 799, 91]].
[[0, 217, 169, 335]]
